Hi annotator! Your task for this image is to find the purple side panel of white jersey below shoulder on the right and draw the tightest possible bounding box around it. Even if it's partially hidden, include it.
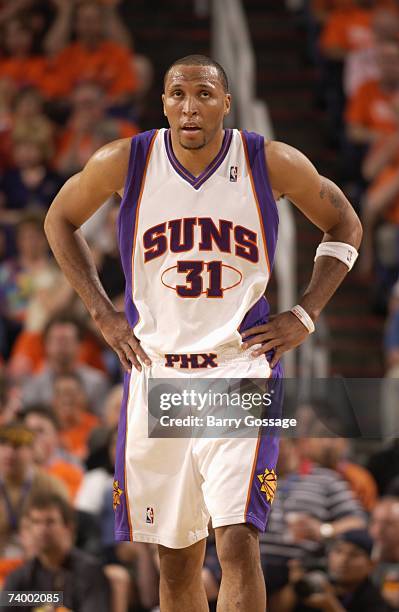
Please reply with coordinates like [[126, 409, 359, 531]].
[[242, 130, 278, 272]]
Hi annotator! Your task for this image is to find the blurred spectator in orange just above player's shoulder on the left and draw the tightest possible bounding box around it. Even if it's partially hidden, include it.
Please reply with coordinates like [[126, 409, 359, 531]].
[[55, 82, 138, 177]]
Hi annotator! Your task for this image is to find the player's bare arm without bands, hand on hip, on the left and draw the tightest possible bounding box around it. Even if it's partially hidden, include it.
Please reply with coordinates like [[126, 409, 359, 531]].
[[44, 139, 149, 371]]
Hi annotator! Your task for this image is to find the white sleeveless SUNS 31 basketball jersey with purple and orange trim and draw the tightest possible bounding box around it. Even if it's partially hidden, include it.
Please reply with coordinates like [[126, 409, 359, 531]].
[[118, 129, 278, 353]]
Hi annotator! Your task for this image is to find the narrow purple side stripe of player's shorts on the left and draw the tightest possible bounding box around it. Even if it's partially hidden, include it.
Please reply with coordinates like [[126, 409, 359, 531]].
[[114, 372, 131, 541]]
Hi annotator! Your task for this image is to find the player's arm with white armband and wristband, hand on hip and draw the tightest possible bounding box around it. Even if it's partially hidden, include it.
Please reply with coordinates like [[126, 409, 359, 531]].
[[242, 142, 362, 367]]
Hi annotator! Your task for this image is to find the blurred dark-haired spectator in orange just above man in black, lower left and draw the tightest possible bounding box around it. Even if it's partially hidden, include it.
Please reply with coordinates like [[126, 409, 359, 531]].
[[24, 405, 83, 500]]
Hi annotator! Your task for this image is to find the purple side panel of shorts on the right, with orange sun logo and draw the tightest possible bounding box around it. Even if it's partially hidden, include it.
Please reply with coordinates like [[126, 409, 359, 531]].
[[245, 372, 283, 531]]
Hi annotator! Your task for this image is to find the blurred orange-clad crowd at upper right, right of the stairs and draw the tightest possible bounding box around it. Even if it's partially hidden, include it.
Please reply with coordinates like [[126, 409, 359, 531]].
[[300, 0, 399, 378]]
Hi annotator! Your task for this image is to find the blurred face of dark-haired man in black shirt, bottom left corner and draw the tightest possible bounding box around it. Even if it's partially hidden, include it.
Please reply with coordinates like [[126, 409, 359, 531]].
[[28, 506, 72, 554]]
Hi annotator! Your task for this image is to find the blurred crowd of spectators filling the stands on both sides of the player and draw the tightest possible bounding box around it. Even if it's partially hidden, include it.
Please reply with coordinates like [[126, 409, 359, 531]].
[[0, 0, 399, 612]]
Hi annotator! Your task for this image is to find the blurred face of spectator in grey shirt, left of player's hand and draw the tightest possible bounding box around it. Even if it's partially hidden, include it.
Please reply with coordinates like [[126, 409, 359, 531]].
[[45, 322, 79, 369]]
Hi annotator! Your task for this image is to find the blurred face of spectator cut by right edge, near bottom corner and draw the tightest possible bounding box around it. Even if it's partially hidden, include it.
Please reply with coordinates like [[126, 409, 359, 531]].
[[369, 500, 399, 560]]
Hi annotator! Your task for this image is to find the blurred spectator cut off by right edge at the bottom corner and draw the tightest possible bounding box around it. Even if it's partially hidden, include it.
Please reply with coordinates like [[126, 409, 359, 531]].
[[370, 497, 399, 610]]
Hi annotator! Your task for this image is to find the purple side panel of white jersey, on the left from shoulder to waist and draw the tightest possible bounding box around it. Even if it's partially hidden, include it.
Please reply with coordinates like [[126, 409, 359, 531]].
[[118, 130, 156, 327]]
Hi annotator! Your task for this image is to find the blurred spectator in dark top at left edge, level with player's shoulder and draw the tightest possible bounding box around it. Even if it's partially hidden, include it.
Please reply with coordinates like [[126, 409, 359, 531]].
[[0, 136, 63, 223]]
